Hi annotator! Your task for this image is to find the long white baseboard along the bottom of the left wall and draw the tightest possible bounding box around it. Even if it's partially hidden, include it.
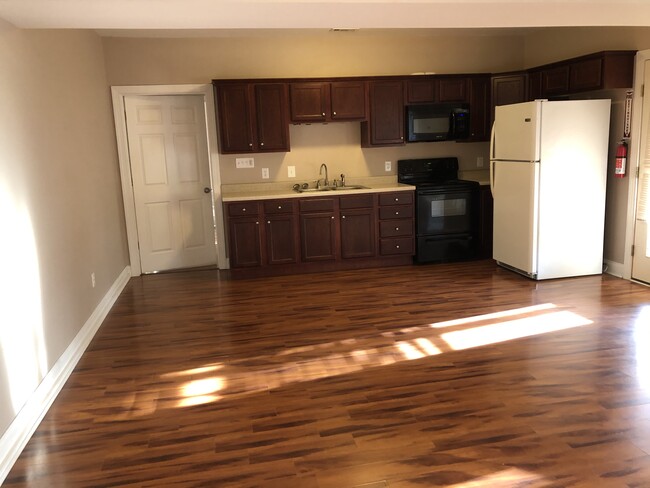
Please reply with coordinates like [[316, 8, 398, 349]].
[[0, 266, 131, 485]]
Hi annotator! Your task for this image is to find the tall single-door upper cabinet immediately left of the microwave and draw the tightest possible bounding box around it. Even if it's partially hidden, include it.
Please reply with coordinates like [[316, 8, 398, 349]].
[[361, 80, 404, 147]]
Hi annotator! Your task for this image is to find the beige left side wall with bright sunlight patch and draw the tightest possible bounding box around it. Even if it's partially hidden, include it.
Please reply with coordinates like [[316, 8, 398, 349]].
[[0, 27, 128, 440]]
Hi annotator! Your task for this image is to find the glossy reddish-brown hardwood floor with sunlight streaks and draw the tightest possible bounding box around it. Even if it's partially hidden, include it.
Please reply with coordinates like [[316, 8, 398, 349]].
[[6, 261, 650, 488]]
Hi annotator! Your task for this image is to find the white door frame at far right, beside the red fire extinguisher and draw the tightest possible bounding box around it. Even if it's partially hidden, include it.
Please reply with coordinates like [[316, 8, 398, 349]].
[[623, 49, 650, 280]]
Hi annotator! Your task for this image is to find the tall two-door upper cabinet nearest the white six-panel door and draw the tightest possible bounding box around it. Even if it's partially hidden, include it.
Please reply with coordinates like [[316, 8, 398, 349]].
[[215, 82, 289, 153]]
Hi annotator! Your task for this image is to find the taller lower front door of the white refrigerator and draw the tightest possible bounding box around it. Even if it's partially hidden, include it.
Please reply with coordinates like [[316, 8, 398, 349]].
[[492, 161, 539, 277]]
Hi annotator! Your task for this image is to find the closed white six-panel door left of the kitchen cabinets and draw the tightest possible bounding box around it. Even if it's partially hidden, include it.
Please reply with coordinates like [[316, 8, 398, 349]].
[[125, 95, 217, 273]]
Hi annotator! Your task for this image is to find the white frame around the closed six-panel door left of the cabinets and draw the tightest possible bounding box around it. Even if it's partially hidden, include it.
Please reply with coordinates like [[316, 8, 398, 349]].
[[111, 84, 229, 276]]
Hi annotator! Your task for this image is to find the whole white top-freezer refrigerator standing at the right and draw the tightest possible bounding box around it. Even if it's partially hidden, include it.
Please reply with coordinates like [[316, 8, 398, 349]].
[[490, 100, 611, 280]]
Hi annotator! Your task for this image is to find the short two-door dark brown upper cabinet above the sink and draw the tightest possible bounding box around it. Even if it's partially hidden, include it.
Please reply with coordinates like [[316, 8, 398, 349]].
[[289, 81, 366, 123]]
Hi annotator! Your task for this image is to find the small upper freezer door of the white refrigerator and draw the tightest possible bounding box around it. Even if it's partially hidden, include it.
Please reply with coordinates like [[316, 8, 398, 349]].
[[490, 101, 542, 161]]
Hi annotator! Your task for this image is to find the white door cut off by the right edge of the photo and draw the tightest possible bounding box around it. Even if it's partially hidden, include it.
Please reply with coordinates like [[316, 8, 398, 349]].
[[632, 61, 650, 283]]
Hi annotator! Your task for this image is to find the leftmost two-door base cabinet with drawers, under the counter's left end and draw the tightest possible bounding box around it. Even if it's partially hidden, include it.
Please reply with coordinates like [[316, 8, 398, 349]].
[[226, 200, 298, 268]]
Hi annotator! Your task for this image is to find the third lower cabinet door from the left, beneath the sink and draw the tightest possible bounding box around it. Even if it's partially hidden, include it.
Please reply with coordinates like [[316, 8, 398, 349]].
[[300, 212, 336, 262]]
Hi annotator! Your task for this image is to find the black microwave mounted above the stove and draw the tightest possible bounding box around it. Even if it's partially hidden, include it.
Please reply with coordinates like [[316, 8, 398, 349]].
[[406, 103, 469, 142]]
